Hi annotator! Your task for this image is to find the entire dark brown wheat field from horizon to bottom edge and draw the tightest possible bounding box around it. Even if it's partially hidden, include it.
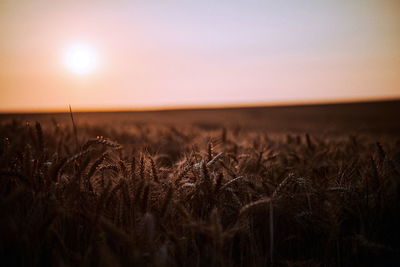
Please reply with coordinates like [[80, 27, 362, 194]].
[[0, 101, 400, 266]]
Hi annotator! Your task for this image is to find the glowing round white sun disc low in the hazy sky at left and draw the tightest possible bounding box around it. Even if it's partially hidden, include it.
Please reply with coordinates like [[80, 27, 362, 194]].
[[64, 43, 98, 75]]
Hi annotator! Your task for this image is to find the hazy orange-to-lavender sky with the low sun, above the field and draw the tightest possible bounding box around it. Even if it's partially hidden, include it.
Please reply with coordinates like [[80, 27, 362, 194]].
[[0, 0, 400, 112]]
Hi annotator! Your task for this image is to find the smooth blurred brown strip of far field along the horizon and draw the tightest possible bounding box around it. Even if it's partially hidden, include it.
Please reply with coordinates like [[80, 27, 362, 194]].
[[0, 101, 400, 134]]
